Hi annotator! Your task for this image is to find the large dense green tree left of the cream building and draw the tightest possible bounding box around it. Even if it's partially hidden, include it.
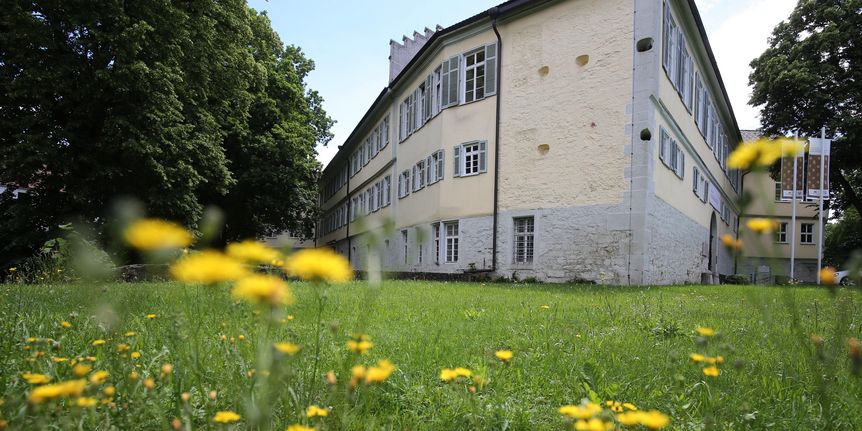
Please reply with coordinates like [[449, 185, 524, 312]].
[[0, 0, 332, 262]]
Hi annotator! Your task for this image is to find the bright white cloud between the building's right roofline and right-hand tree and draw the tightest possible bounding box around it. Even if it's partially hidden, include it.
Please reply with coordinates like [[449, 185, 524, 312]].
[[709, 0, 795, 129]]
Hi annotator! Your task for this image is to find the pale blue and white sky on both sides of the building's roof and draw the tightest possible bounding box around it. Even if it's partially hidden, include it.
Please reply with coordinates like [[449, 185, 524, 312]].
[[249, 0, 795, 168]]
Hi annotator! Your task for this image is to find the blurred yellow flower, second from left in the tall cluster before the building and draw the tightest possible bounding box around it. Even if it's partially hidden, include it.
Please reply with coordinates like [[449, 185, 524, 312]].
[[170, 250, 249, 283]]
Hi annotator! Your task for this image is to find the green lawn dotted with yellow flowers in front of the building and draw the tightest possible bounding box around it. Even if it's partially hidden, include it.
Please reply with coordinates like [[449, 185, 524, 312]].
[[0, 281, 862, 430]]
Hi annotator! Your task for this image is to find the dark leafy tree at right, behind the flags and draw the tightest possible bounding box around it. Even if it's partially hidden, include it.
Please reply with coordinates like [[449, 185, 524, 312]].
[[749, 0, 862, 236]]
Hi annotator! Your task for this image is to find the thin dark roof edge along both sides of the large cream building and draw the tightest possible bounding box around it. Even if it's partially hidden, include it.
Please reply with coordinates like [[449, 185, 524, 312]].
[[324, 0, 745, 175]]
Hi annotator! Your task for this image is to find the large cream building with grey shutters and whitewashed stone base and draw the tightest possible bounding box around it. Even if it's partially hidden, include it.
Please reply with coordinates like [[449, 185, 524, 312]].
[[317, 0, 741, 284]]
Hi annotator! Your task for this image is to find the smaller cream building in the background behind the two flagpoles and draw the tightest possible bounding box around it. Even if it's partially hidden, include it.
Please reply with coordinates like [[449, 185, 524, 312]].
[[737, 130, 825, 283]]
